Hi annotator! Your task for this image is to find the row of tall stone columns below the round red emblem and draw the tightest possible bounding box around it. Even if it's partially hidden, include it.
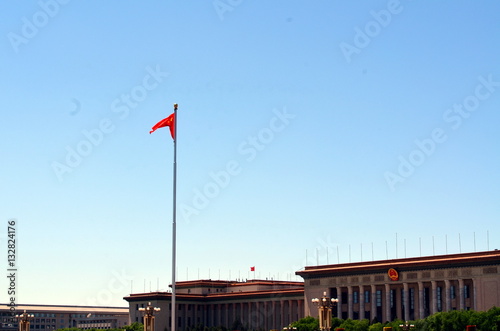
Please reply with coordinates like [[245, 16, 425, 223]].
[[336, 279, 476, 321]]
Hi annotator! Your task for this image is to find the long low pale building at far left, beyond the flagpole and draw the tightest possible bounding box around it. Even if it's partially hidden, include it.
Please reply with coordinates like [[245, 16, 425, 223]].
[[0, 304, 129, 331]]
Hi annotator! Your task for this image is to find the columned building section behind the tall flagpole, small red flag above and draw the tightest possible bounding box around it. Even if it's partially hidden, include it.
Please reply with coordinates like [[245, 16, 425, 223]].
[[124, 280, 304, 331]]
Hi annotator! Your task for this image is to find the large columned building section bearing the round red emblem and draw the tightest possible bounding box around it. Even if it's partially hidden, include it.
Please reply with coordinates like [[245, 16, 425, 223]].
[[296, 250, 500, 322]]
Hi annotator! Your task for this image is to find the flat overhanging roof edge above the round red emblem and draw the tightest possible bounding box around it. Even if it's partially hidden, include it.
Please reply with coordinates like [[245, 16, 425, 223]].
[[295, 250, 500, 279]]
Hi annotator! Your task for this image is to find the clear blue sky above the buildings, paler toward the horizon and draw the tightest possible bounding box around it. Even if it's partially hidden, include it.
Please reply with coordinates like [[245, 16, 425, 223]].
[[0, 0, 500, 306]]
